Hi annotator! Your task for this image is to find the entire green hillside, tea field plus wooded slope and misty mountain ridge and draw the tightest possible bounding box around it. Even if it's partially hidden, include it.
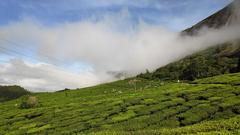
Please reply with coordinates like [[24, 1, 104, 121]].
[[0, 1, 240, 135]]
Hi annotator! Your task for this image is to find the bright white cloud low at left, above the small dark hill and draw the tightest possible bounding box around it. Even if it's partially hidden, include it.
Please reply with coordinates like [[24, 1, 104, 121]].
[[0, 59, 100, 91]]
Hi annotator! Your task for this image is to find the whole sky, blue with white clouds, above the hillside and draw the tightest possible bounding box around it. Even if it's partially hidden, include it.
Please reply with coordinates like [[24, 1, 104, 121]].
[[0, 0, 235, 91]]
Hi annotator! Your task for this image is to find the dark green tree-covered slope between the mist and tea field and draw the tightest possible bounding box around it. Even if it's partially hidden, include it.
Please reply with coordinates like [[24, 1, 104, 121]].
[[138, 42, 240, 80]]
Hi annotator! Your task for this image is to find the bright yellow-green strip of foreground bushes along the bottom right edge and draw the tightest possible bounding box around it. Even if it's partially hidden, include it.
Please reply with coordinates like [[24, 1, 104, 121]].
[[90, 116, 240, 135]]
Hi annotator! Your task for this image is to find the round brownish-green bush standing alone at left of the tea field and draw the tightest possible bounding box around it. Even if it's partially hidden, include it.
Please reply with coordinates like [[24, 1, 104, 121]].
[[20, 95, 39, 109]]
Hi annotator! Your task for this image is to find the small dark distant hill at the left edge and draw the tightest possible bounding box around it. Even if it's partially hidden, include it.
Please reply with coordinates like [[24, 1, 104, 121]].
[[0, 86, 29, 102]]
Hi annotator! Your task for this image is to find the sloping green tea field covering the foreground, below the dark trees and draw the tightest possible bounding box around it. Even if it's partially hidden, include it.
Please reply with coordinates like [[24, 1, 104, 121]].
[[0, 74, 240, 134]]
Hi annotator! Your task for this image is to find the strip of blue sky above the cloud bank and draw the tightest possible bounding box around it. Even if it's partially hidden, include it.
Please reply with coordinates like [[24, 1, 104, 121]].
[[0, 0, 230, 30]]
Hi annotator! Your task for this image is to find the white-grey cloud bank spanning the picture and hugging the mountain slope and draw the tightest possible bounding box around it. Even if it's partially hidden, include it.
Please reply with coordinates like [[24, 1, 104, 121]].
[[0, 7, 240, 91]]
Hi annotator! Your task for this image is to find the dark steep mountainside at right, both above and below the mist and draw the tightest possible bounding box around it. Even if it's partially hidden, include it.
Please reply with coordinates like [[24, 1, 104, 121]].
[[139, 0, 240, 80]]
